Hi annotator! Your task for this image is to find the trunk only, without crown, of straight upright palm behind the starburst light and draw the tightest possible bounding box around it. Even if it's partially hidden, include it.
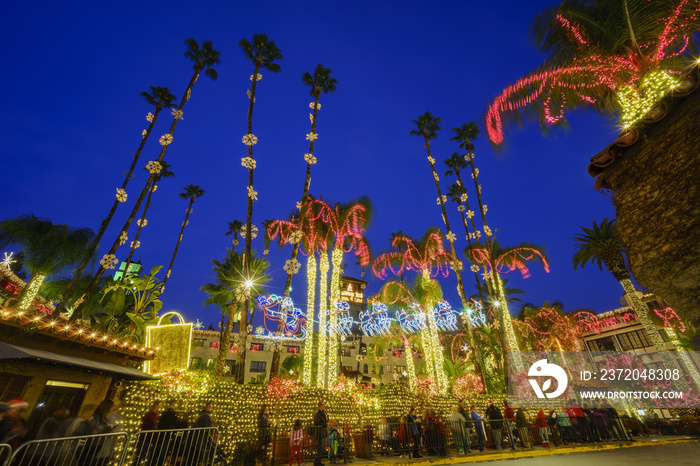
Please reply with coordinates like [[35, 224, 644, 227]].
[[236, 64, 262, 384]]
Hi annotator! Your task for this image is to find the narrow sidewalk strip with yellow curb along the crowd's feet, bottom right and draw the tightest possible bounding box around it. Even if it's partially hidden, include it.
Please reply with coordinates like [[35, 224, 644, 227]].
[[341, 435, 700, 466]]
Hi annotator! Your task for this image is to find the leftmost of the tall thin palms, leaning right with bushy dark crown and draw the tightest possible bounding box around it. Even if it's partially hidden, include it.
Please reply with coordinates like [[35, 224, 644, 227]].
[[54, 86, 175, 315]]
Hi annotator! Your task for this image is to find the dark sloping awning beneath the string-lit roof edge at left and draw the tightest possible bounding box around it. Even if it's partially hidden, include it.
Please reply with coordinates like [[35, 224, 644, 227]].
[[0, 343, 157, 380]]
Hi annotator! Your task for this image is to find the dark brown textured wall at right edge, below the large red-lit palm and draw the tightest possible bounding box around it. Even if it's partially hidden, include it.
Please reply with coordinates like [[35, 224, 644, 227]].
[[602, 90, 700, 334]]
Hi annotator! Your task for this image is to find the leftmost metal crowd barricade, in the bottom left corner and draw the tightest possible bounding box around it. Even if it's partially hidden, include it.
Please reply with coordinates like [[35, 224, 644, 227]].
[[6, 432, 127, 466]]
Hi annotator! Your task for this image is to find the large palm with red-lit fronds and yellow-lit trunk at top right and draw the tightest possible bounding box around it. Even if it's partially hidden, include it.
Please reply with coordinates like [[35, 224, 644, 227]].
[[486, 0, 700, 144]]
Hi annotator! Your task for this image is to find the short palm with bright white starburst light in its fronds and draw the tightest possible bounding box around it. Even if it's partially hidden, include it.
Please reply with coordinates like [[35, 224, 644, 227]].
[[201, 248, 270, 377]]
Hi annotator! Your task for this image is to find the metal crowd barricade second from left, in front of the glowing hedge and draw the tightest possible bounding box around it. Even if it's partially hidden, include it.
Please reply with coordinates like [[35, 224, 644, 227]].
[[119, 427, 219, 466]]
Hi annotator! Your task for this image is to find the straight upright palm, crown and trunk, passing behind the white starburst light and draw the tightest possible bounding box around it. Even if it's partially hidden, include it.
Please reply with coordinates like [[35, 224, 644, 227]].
[[237, 34, 282, 383]]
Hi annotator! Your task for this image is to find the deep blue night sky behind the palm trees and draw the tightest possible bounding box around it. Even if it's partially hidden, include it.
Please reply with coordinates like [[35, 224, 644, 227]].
[[0, 1, 622, 324]]
